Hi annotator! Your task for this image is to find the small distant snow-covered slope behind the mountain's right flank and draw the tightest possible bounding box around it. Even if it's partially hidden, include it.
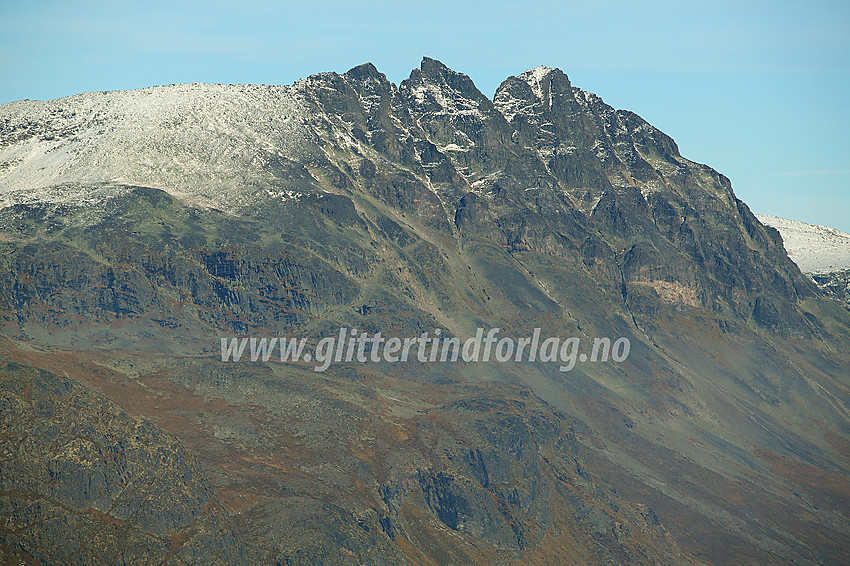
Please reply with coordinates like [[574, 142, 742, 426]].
[[756, 214, 850, 273]]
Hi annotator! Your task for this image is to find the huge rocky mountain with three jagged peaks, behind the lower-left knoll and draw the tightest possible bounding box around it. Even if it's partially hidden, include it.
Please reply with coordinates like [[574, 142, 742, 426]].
[[0, 58, 850, 564]]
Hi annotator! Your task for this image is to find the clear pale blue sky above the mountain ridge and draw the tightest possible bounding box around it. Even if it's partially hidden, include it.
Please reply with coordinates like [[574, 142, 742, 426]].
[[0, 0, 850, 232]]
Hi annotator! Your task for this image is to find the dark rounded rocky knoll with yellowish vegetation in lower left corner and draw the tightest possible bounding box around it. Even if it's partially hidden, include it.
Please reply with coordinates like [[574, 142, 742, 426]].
[[0, 363, 249, 565]]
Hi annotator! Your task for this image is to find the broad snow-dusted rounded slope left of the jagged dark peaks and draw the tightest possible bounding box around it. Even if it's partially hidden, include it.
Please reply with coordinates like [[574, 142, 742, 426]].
[[0, 84, 309, 208]]
